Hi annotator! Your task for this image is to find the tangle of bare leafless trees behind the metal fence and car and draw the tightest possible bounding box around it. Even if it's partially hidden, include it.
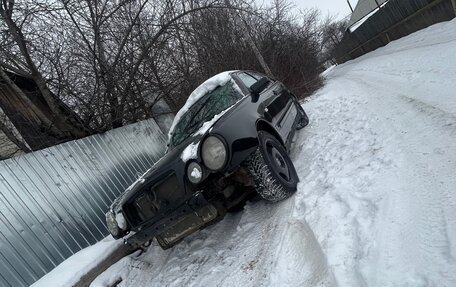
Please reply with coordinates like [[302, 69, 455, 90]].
[[0, 0, 323, 158]]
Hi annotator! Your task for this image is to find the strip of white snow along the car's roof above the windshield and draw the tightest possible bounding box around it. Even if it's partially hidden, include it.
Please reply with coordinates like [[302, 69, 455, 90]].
[[168, 70, 237, 137]]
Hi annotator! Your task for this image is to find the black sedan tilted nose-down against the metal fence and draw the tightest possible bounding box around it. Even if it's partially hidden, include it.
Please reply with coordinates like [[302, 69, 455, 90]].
[[106, 71, 309, 249]]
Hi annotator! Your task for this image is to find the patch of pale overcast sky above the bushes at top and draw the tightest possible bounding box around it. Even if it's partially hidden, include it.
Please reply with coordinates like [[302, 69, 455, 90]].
[[266, 0, 358, 19]]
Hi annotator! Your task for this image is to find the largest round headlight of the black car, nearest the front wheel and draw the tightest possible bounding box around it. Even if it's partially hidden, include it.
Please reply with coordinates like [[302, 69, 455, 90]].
[[201, 136, 226, 170]]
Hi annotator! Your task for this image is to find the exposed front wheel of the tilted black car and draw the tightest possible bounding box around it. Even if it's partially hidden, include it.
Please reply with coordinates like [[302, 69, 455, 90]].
[[248, 131, 299, 202]]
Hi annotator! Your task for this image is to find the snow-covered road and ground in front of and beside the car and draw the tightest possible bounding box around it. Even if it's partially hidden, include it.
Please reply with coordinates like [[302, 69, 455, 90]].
[[33, 20, 456, 286]]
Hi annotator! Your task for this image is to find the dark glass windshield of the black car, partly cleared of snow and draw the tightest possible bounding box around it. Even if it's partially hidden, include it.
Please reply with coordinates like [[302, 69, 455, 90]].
[[169, 82, 242, 148]]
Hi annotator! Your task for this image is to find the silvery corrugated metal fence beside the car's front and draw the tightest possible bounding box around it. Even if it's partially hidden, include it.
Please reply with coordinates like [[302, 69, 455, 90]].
[[0, 120, 166, 286]]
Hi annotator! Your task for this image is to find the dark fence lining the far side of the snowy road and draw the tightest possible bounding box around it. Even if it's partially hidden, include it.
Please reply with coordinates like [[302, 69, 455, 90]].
[[334, 0, 456, 64]]
